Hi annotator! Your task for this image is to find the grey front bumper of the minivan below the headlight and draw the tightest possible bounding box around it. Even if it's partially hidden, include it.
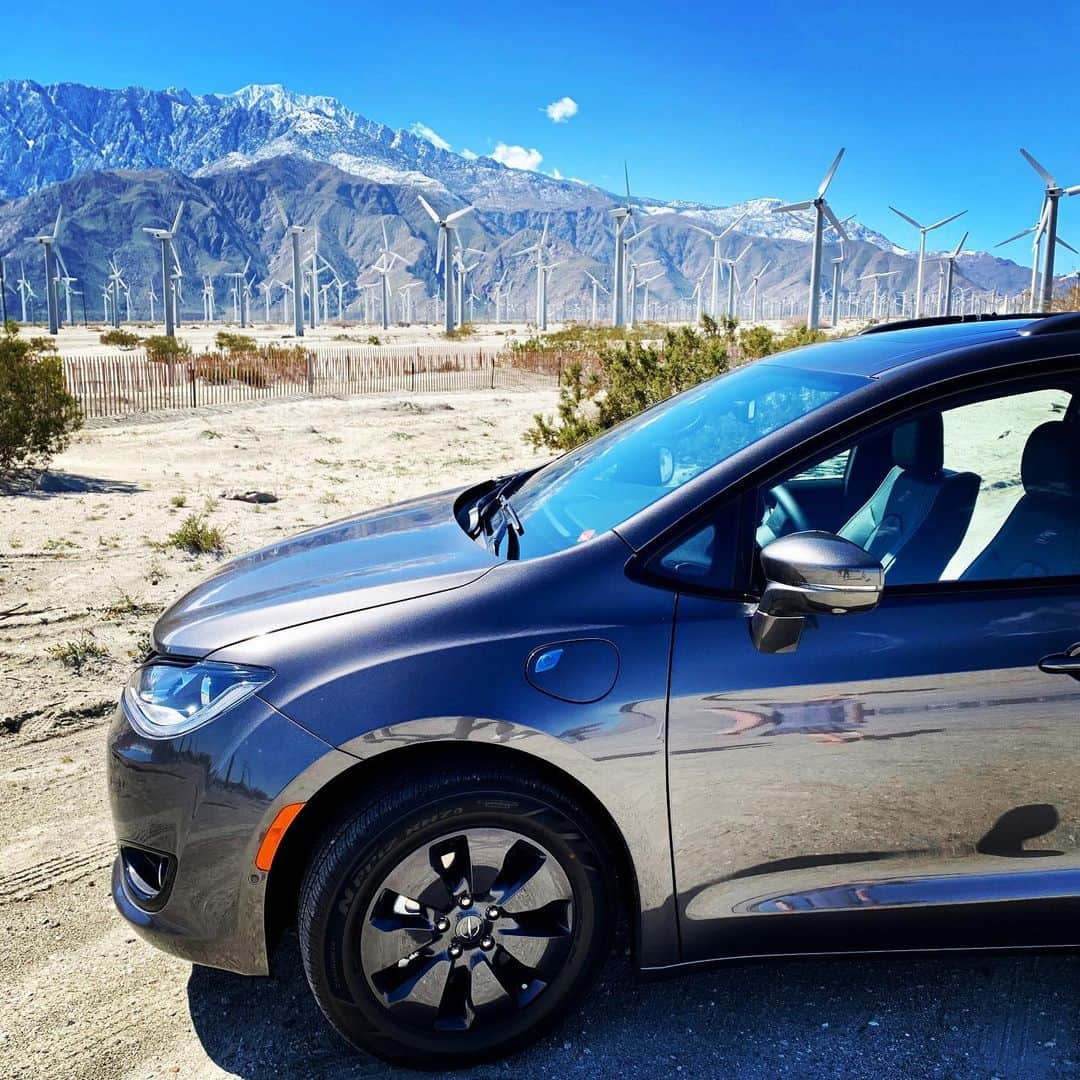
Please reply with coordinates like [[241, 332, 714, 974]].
[[108, 697, 355, 975]]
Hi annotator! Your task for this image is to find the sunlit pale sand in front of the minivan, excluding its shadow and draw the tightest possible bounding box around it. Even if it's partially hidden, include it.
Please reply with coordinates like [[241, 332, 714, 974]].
[[0, 391, 554, 1077]]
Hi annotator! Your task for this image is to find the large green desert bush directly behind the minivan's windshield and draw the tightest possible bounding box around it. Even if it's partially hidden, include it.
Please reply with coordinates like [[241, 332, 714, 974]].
[[525, 327, 728, 450]]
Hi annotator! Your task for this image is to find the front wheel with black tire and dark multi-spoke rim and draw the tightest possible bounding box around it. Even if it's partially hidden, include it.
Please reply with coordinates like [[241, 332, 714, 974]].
[[298, 767, 617, 1069]]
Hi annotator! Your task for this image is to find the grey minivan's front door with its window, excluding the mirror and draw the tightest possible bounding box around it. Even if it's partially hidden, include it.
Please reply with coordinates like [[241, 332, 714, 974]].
[[669, 390, 1080, 960]]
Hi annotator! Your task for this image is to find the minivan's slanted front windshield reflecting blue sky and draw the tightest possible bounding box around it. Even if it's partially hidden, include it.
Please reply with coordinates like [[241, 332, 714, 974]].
[[501, 364, 865, 558]]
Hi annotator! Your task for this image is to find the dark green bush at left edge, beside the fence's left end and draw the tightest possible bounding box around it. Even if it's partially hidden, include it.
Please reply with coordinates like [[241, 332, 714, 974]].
[[0, 333, 82, 476]]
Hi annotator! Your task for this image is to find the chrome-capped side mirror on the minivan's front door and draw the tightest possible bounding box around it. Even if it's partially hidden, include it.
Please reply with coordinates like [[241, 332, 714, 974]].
[[750, 532, 885, 652]]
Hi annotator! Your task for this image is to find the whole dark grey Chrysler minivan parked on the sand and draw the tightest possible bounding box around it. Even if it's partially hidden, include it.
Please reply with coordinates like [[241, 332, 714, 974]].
[[109, 314, 1080, 1067]]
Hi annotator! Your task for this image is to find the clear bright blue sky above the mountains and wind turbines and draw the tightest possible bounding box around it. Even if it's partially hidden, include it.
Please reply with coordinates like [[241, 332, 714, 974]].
[[8, 0, 1080, 271]]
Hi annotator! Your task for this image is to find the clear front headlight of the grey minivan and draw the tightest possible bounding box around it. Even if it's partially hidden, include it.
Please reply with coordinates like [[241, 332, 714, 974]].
[[124, 660, 273, 739]]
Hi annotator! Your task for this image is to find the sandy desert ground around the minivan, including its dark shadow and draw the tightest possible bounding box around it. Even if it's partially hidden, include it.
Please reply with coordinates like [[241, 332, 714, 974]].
[[0, 391, 1080, 1080]]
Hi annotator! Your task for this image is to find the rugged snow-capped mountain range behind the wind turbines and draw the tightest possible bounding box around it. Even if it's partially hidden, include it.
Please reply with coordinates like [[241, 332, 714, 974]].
[[0, 80, 1027, 310]]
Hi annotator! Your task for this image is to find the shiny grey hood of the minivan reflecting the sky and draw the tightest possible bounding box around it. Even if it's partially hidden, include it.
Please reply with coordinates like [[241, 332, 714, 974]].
[[153, 491, 494, 657]]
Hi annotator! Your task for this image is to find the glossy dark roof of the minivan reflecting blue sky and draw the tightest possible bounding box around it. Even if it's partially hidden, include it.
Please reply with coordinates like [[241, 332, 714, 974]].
[[765, 315, 1054, 378]]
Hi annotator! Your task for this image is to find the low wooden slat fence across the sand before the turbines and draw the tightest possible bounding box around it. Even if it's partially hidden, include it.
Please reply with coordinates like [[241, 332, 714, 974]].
[[64, 343, 562, 418]]
